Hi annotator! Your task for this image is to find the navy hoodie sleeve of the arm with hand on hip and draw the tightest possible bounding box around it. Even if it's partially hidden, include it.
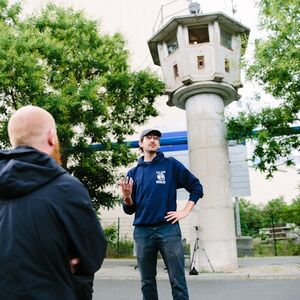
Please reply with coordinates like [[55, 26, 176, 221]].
[[175, 160, 203, 203]]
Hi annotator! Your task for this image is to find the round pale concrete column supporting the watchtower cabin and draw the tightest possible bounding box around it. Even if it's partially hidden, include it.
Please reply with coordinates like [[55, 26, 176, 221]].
[[185, 93, 237, 272]]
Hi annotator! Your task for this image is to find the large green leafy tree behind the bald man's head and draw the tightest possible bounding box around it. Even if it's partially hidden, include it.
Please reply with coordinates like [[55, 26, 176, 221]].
[[0, 0, 164, 209]]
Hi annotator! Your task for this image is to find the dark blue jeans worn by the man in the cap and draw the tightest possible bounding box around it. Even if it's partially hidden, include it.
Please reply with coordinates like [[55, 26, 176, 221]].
[[134, 223, 189, 300]]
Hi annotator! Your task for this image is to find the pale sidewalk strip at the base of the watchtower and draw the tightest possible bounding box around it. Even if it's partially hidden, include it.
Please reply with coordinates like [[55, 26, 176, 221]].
[[96, 256, 300, 280]]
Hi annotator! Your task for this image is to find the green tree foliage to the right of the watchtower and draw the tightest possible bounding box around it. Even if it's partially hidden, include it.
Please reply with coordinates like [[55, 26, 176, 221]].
[[227, 0, 300, 177]]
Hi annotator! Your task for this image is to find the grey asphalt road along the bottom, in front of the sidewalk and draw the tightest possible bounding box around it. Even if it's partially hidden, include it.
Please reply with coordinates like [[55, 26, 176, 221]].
[[93, 279, 300, 300]]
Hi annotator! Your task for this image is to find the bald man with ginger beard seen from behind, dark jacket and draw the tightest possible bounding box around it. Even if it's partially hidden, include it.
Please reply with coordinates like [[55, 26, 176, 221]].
[[0, 106, 106, 300]]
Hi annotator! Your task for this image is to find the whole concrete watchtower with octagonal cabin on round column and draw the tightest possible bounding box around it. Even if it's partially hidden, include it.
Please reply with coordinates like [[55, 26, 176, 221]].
[[148, 12, 249, 272]]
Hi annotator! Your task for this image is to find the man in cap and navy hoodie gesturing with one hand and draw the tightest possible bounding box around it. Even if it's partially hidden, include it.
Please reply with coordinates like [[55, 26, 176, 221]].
[[120, 129, 203, 300]]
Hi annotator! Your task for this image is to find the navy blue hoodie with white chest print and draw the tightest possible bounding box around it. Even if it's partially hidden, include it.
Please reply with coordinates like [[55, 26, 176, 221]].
[[123, 152, 203, 226]]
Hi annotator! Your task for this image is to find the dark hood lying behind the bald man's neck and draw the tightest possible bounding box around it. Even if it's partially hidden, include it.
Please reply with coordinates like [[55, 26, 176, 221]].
[[0, 147, 66, 200]]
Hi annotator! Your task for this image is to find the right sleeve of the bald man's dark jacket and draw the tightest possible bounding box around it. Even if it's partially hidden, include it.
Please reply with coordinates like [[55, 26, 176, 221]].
[[58, 178, 107, 275]]
